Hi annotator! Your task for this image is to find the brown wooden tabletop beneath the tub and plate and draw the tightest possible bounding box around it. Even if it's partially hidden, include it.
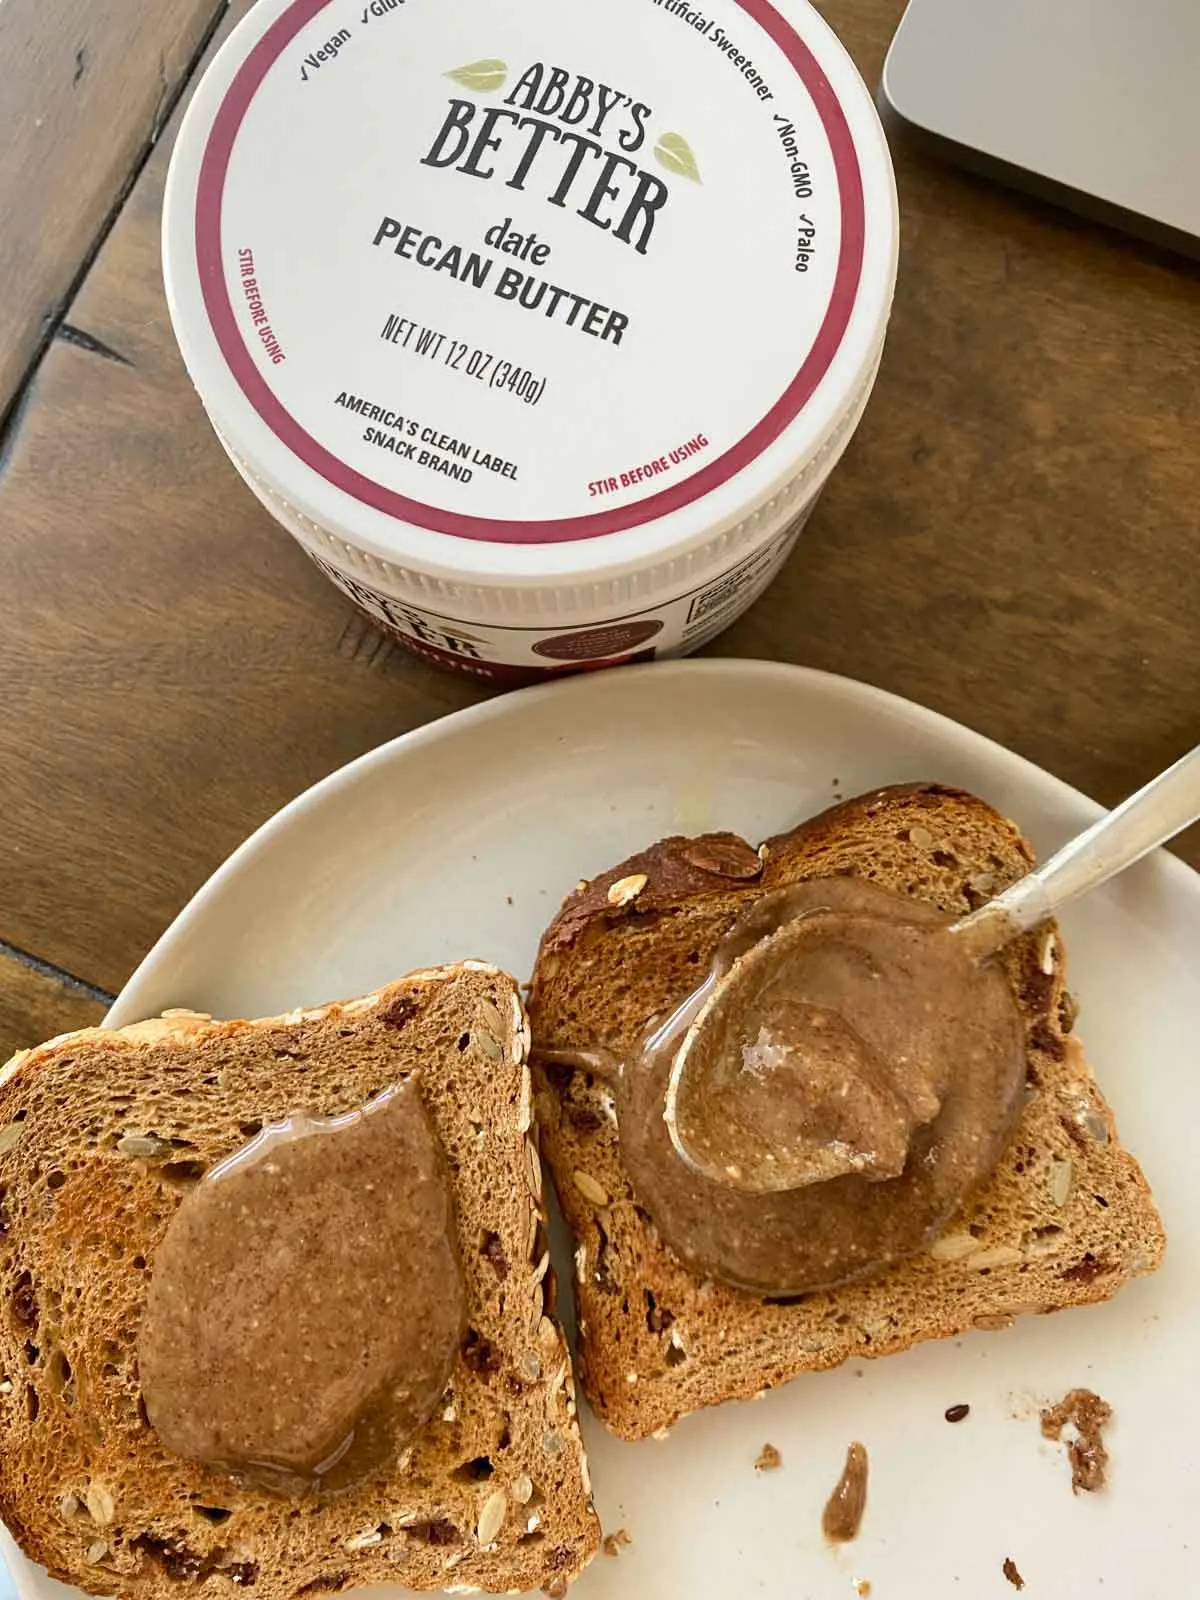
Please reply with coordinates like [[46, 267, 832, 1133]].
[[0, 0, 1200, 1054]]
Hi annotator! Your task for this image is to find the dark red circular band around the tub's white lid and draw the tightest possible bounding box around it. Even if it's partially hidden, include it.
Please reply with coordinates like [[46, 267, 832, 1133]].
[[195, 0, 866, 544]]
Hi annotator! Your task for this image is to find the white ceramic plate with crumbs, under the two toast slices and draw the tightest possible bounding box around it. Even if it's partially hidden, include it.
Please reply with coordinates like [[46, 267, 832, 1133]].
[[4, 661, 1200, 1600]]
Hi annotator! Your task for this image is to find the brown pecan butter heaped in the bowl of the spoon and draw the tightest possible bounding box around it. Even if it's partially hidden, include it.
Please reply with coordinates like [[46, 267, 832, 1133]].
[[667, 910, 947, 1190]]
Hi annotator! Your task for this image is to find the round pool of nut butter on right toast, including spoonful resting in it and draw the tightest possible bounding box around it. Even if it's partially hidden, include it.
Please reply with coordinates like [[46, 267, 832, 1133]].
[[614, 877, 1026, 1294]]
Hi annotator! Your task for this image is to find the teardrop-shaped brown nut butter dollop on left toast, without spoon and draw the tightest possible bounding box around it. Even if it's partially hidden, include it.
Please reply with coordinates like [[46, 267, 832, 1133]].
[[138, 1078, 466, 1494]]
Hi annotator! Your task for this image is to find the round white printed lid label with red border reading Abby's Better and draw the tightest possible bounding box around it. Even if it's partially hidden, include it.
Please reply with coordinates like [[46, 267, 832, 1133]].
[[185, 0, 866, 542]]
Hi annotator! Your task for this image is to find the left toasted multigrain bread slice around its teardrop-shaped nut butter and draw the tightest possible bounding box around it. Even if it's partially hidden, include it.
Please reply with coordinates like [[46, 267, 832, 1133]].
[[0, 962, 598, 1600]]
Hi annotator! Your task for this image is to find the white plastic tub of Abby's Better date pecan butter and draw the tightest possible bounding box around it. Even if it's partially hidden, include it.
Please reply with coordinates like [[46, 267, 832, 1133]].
[[163, 0, 898, 683]]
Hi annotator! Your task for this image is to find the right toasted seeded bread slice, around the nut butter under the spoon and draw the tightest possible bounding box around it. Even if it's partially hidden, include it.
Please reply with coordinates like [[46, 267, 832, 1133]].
[[530, 784, 1165, 1438]]
